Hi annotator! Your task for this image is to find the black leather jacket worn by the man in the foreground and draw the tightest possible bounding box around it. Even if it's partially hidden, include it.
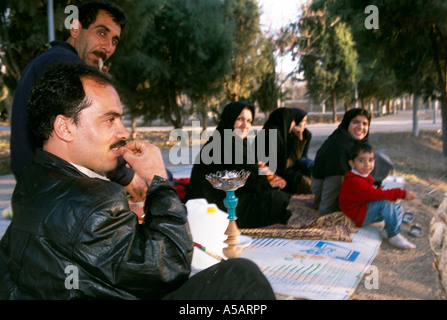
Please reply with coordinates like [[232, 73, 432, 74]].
[[0, 150, 193, 299]]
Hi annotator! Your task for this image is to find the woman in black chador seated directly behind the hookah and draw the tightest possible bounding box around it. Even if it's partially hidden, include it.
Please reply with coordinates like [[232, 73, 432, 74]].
[[184, 101, 291, 228]]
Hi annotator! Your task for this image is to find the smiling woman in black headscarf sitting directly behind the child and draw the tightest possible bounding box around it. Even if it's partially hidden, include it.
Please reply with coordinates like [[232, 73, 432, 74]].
[[311, 108, 371, 215]]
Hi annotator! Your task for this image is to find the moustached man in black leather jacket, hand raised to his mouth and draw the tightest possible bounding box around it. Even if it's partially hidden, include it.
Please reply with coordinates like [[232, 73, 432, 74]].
[[0, 64, 274, 299]]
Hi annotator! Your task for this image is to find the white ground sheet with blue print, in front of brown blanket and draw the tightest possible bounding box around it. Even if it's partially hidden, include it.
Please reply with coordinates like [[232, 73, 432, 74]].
[[242, 226, 381, 300]]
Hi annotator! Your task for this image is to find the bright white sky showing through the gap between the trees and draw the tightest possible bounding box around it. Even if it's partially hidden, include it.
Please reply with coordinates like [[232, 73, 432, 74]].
[[258, 0, 305, 74]]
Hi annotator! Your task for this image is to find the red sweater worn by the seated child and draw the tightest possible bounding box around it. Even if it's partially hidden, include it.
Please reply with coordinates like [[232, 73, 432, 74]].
[[338, 171, 407, 227]]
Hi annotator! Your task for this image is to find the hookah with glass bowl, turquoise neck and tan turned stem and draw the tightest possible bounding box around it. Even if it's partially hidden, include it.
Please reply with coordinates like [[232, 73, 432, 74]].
[[206, 170, 250, 258]]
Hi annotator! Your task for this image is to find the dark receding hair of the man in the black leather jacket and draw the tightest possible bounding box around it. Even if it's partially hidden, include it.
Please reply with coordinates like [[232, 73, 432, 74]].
[[27, 63, 112, 145]]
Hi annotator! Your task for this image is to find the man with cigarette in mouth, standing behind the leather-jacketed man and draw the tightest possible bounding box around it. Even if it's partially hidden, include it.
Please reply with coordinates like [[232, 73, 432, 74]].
[[10, 0, 146, 202]]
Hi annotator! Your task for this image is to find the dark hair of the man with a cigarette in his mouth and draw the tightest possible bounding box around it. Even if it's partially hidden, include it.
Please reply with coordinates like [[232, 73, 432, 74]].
[[79, 0, 127, 33]]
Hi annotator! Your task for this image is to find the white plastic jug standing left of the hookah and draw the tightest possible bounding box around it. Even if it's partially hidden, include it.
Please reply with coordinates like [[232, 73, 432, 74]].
[[186, 199, 228, 270]]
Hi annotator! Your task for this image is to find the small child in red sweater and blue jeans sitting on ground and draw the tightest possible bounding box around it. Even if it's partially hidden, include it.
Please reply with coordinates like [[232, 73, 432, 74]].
[[339, 143, 416, 249]]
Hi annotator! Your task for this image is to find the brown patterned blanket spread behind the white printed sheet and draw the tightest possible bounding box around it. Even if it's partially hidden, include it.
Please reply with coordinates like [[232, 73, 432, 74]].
[[240, 195, 358, 242]]
